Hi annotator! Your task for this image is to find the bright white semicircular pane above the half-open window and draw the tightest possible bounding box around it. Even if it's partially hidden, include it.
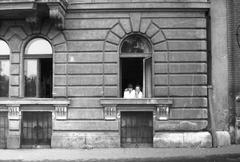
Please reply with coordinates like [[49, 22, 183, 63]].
[[25, 38, 52, 54]]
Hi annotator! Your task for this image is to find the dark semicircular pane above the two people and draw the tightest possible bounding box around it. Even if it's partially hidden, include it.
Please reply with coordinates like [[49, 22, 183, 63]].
[[121, 36, 150, 53]]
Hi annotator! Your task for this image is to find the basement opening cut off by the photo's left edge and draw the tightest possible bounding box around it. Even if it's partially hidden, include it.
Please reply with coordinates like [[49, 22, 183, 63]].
[[0, 111, 8, 149]]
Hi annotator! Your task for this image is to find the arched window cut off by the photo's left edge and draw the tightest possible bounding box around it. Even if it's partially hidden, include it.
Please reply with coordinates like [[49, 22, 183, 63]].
[[0, 39, 10, 97]]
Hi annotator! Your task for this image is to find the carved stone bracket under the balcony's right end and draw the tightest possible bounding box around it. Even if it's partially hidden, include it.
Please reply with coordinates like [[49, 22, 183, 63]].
[[48, 3, 66, 29]]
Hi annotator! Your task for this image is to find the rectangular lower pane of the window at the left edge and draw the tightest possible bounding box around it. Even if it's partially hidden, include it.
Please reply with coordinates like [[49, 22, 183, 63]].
[[0, 60, 10, 97]]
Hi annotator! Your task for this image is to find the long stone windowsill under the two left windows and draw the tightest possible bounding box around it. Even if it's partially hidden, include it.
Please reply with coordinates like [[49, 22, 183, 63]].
[[0, 98, 70, 105]]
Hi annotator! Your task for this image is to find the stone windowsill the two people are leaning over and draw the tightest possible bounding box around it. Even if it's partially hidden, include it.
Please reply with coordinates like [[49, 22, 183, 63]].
[[100, 98, 173, 105]]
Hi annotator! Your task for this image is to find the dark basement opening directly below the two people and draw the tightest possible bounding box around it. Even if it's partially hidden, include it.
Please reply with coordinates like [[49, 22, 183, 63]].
[[121, 112, 153, 147]]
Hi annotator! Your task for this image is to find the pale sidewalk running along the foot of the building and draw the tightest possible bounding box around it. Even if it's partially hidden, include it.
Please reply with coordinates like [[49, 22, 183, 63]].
[[0, 145, 240, 162]]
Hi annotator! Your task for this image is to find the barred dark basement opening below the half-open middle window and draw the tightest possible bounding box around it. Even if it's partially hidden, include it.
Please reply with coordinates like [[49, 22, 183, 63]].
[[21, 112, 52, 145]]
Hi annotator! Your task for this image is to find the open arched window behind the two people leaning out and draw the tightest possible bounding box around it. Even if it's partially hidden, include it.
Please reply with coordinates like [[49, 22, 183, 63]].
[[119, 35, 152, 98]]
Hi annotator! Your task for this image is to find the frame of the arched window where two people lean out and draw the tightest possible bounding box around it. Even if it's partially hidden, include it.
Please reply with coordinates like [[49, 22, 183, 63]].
[[118, 34, 154, 98]]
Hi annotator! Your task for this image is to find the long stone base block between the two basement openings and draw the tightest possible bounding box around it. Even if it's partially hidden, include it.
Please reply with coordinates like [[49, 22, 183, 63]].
[[51, 132, 120, 149]]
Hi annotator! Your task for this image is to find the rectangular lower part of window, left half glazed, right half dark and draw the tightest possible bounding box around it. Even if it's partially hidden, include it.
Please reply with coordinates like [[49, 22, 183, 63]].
[[24, 58, 52, 98]]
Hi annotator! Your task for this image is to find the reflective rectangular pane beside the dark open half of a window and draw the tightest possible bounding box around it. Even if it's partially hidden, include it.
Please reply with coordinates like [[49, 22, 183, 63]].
[[24, 60, 37, 97]]
